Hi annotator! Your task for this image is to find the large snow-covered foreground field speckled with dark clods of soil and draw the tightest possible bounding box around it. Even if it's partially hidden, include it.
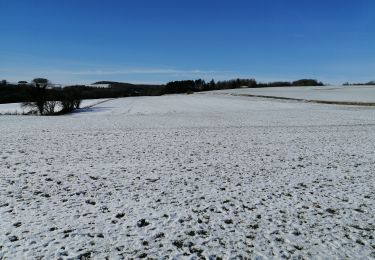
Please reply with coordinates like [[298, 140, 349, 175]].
[[0, 93, 375, 259]]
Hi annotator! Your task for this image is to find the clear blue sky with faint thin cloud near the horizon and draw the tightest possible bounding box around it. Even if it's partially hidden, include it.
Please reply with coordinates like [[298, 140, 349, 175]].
[[0, 0, 375, 83]]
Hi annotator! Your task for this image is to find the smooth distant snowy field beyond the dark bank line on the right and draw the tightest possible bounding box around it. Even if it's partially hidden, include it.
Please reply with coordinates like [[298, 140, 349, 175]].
[[217, 86, 375, 103]]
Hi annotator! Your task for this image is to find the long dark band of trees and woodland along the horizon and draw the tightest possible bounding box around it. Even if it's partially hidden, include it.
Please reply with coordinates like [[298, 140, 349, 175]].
[[0, 78, 323, 104]]
